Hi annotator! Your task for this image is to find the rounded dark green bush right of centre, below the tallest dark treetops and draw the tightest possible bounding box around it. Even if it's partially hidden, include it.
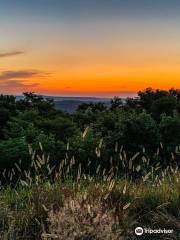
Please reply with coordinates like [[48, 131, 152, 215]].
[[112, 112, 159, 152]]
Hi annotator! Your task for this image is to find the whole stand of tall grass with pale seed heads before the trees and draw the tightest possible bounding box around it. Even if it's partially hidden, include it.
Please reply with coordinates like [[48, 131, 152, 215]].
[[0, 138, 180, 240]]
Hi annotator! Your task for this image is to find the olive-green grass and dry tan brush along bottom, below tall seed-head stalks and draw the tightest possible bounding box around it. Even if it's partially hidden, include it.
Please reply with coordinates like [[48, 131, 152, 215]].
[[0, 172, 180, 240]]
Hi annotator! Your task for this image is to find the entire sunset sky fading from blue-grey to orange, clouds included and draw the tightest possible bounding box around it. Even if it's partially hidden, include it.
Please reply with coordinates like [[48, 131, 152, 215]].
[[0, 0, 180, 97]]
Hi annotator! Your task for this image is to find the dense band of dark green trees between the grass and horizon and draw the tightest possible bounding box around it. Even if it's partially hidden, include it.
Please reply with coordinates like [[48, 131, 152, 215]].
[[0, 88, 180, 178]]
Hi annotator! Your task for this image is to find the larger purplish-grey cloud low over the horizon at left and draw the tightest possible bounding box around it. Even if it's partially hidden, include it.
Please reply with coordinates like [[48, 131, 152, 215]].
[[0, 70, 41, 89]]
